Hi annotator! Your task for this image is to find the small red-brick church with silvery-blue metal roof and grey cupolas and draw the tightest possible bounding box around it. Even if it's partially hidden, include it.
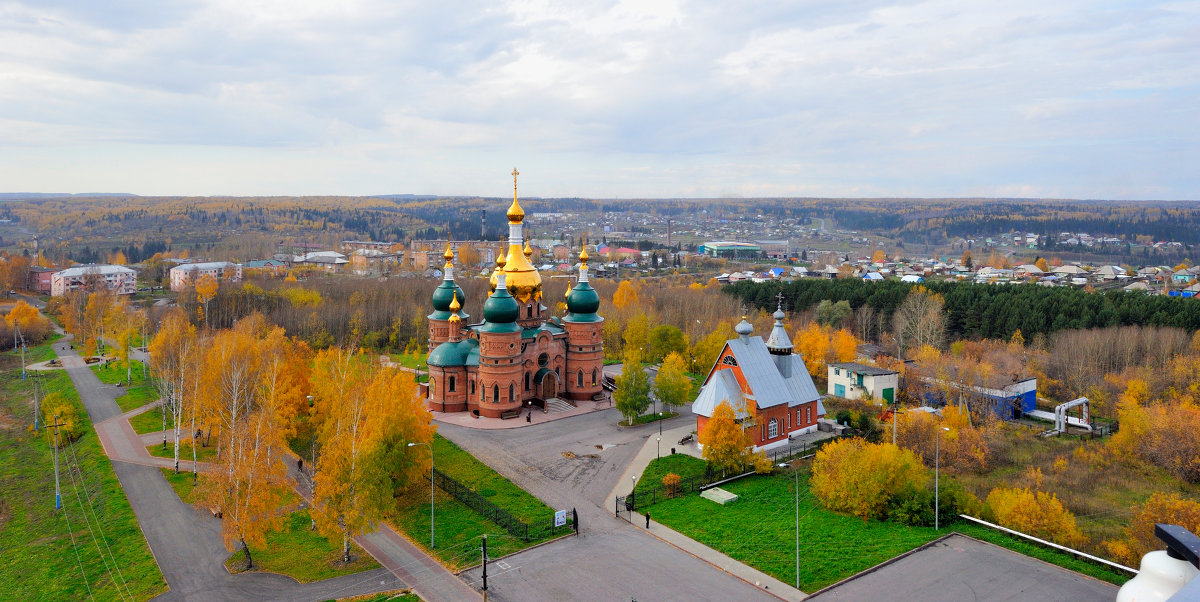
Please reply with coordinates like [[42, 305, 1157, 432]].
[[691, 307, 824, 451]]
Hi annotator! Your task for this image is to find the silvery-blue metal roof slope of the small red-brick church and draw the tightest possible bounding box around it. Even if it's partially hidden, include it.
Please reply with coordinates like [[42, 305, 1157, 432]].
[[725, 337, 821, 408]]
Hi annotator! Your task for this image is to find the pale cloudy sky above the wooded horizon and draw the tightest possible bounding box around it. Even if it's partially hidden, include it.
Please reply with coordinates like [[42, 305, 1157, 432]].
[[0, 0, 1200, 200]]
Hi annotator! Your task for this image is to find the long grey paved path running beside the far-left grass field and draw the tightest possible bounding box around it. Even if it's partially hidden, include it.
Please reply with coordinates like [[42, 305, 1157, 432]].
[[54, 343, 415, 601]]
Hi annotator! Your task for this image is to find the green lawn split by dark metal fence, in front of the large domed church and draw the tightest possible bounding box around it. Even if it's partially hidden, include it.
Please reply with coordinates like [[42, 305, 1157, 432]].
[[391, 437, 566, 568]]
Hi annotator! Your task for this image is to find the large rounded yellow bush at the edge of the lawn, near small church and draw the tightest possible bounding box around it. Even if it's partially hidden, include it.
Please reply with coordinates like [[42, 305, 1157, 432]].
[[810, 437, 929, 520]]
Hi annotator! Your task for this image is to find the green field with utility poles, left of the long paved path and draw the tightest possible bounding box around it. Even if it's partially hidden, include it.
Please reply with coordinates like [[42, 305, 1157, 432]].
[[0, 344, 167, 600]]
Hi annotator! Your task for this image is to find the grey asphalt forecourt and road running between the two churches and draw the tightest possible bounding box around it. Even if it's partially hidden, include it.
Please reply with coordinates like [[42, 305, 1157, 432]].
[[438, 409, 775, 601]]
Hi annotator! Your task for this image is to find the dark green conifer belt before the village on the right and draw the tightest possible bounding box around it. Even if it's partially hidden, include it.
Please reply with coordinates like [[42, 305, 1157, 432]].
[[725, 278, 1200, 339]]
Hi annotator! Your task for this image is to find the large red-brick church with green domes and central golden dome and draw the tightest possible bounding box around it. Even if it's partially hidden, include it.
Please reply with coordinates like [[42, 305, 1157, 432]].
[[426, 169, 604, 417]]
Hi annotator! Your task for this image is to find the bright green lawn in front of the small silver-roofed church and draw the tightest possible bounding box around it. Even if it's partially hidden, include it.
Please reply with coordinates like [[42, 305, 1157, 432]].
[[644, 458, 1128, 592]]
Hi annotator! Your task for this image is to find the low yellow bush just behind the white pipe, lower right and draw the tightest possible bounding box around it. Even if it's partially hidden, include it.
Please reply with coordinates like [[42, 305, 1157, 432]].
[[985, 487, 1086, 546]]
